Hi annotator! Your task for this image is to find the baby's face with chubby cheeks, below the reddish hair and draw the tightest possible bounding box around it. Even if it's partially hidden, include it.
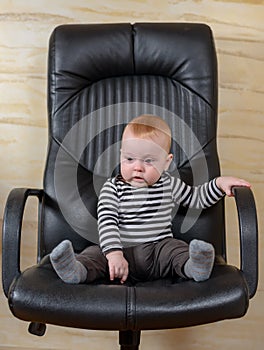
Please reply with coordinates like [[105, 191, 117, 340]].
[[121, 131, 172, 187]]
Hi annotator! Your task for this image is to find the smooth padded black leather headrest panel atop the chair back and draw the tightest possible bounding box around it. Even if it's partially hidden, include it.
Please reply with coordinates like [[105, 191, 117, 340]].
[[48, 23, 217, 114]]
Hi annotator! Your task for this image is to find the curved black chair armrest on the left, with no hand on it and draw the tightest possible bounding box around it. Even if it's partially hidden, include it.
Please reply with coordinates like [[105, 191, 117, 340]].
[[2, 188, 43, 296]]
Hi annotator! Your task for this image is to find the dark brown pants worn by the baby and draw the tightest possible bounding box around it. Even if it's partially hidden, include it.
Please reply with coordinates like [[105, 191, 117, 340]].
[[76, 238, 189, 283]]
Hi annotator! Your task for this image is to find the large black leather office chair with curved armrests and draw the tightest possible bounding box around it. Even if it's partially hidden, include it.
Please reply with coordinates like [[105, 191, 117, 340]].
[[3, 23, 258, 349]]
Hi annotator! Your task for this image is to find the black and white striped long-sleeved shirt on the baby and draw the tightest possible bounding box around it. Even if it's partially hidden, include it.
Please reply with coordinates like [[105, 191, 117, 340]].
[[98, 172, 224, 253]]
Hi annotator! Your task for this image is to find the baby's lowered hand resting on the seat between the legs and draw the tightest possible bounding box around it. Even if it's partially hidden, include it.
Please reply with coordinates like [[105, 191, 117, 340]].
[[106, 250, 128, 284]]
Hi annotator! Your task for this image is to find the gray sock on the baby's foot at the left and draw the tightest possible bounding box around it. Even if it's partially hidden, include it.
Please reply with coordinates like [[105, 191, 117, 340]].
[[50, 240, 87, 284]]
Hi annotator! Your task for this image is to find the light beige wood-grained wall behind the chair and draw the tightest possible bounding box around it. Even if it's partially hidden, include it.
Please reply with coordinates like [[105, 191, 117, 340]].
[[0, 0, 264, 350]]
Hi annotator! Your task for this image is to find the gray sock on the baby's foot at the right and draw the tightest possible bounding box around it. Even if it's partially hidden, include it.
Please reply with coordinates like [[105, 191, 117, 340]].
[[184, 239, 215, 282]]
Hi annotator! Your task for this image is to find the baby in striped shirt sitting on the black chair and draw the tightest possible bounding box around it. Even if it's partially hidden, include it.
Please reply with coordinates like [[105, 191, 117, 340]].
[[50, 115, 250, 283]]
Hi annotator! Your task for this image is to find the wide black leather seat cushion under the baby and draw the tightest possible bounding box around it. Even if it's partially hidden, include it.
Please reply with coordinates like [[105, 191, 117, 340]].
[[9, 257, 248, 330]]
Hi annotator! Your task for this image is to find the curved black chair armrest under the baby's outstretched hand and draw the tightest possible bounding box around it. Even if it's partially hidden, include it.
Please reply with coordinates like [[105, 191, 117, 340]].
[[233, 187, 258, 298]]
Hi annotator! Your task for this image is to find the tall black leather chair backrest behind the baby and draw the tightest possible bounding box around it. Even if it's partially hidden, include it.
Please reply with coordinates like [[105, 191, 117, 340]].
[[41, 23, 225, 255]]
